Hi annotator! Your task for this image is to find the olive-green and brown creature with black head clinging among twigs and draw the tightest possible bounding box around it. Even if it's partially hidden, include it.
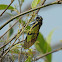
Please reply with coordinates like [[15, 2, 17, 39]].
[[24, 15, 43, 49]]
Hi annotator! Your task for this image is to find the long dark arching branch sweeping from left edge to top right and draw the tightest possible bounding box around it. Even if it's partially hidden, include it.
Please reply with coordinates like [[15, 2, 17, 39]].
[[0, 1, 62, 30]]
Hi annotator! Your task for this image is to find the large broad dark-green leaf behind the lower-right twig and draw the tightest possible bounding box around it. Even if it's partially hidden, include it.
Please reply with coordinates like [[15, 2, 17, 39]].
[[35, 32, 52, 62]]
